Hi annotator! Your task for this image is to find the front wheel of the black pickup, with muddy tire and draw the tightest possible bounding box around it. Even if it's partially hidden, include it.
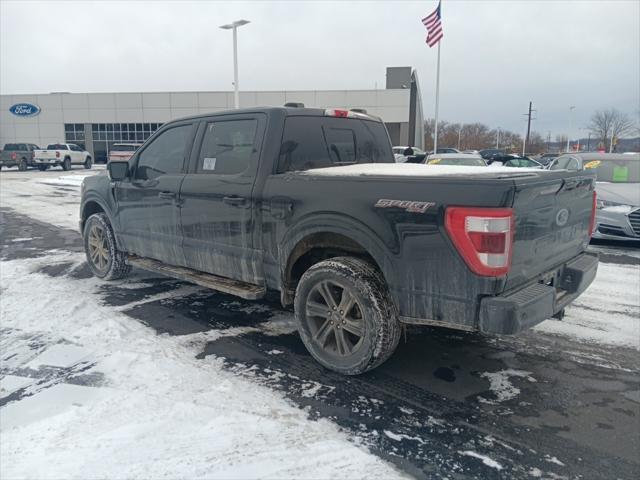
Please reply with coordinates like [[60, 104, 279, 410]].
[[83, 213, 131, 280]]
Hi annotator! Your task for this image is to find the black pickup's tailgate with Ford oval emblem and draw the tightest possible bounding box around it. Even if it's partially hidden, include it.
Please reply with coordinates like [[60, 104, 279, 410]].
[[505, 171, 595, 290]]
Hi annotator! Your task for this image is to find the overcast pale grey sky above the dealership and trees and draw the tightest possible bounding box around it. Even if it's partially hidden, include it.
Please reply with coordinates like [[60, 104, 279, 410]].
[[0, 0, 640, 136]]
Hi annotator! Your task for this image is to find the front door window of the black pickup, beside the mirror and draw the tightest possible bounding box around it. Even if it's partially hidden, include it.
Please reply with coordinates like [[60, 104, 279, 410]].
[[135, 125, 192, 180]]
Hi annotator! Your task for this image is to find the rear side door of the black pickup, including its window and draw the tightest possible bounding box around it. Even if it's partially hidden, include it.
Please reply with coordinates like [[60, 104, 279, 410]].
[[180, 114, 266, 284]]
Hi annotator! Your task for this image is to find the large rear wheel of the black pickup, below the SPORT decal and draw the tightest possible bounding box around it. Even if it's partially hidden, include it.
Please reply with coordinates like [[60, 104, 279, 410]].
[[295, 257, 400, 375]]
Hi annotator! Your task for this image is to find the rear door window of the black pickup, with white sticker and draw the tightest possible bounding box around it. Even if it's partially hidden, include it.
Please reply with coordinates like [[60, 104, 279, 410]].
[[197, 119, 258, 175]]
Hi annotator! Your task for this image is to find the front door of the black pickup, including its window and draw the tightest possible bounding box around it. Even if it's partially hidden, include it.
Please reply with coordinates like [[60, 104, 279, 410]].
[[114, 122, 195, 266]]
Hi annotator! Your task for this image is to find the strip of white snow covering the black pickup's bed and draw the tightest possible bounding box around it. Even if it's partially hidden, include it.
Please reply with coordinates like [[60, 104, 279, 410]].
[[297, 163, 548, 177]]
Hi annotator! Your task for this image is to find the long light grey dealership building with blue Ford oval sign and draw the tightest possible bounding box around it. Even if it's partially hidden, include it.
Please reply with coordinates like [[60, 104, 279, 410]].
[[0, 67, 424, 161]]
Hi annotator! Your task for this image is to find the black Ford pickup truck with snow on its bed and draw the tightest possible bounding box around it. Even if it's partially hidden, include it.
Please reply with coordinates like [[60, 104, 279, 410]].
[[80, 107, 598, 374]]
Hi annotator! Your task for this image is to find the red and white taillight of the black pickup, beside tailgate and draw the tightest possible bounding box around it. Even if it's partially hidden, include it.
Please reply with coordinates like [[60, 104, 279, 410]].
[[444, 207, 515, 277]]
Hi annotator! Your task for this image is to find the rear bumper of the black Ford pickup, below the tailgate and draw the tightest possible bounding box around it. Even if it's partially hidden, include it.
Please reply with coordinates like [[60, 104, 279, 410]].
[[478, 253, 598, 334]]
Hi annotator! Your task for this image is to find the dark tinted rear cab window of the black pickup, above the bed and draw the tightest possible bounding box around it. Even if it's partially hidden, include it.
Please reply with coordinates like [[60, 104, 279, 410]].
[[278, 116, 395, 173]]
